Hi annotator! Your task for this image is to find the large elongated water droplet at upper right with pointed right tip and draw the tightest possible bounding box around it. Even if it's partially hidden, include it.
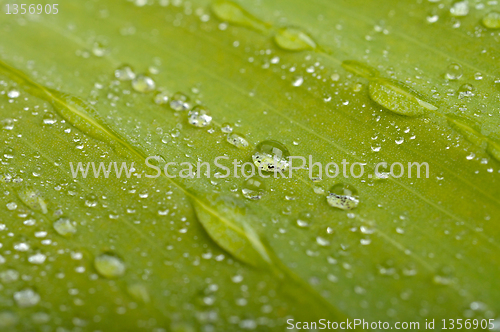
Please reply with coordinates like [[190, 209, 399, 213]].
[[368, 78, 437, 116]]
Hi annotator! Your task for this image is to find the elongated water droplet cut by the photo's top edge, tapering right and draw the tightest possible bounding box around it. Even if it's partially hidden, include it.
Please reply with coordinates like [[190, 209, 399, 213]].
[[212, 0, 268, 32]]
